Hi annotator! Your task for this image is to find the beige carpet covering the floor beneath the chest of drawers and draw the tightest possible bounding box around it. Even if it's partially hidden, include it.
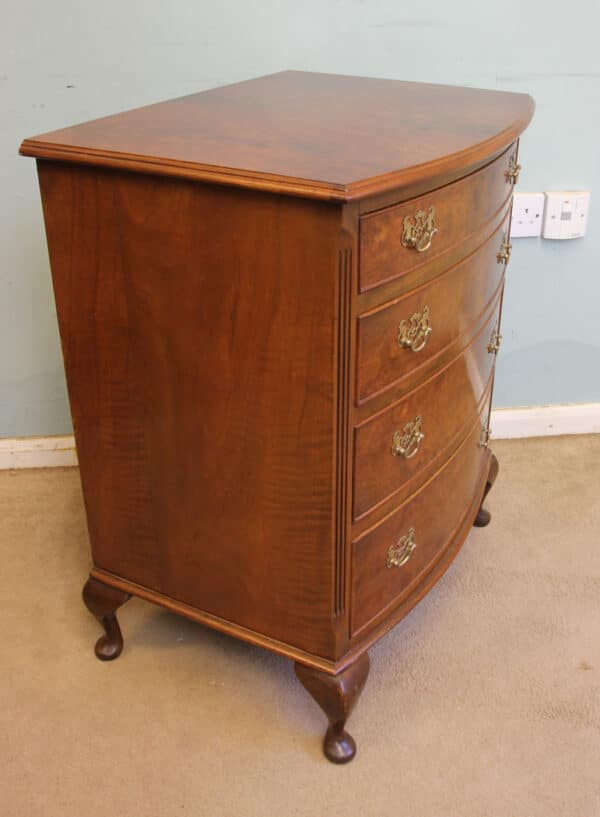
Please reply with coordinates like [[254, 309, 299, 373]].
[[0, 436, 600, 817]]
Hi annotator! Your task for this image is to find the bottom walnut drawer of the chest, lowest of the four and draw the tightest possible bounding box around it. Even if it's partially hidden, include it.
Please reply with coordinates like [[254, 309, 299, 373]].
[[351, 410, 487, 635]]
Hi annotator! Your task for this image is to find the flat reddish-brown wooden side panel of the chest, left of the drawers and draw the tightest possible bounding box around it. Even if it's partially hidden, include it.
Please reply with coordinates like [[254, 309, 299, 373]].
[[39, 162, 341, 656]]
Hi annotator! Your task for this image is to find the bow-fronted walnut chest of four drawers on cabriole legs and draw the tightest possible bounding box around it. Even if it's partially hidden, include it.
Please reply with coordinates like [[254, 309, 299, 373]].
[[21, 72, 533, 762]]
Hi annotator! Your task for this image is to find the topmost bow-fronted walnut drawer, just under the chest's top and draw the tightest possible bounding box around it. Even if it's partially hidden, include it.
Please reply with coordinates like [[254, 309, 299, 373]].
[[359, 145, 516, 292]]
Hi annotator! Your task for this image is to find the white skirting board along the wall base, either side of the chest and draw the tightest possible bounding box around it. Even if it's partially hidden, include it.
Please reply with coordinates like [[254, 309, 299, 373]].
[[0, 403, 600, 470]]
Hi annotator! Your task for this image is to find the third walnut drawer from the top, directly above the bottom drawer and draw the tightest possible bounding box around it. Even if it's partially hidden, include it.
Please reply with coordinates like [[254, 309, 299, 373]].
[[353, 296, 500, 520]]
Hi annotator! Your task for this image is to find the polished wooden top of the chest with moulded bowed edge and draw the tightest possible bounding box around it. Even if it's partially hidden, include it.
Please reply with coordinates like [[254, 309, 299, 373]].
[[20, 71, 533, 201]]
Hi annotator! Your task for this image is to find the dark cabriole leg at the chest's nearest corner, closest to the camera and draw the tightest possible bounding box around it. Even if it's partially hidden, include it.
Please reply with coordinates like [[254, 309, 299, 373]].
[[294, 652, 370, 763]]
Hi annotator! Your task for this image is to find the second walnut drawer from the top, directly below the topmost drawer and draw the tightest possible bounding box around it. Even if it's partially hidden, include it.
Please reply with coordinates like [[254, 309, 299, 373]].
[[356, 214, 508, 405]]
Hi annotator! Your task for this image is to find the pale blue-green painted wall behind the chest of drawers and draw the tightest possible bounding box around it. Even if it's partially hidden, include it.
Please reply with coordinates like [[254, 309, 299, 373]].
[[0, 0, 600, 437]]
